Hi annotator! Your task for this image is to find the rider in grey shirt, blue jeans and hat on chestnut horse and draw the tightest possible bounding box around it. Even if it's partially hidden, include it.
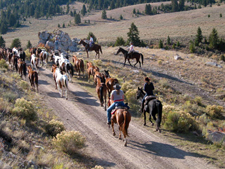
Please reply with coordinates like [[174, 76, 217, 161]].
[[107, 84, 129, 125]]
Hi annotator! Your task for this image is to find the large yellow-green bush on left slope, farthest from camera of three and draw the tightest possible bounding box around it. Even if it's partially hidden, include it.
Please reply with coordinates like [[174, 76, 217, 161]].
[[12, 98, 37, 121]]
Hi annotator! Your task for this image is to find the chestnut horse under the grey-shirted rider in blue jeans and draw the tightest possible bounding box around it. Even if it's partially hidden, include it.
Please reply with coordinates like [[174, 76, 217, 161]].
[[108, 100, 131, 146]]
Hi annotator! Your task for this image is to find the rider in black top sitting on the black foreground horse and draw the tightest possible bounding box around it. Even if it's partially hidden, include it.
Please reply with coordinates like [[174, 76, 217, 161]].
[[140, 77, 154, 112]]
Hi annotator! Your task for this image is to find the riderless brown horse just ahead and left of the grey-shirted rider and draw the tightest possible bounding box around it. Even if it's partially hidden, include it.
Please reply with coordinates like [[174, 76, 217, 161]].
[[96, 72, 107, 110]]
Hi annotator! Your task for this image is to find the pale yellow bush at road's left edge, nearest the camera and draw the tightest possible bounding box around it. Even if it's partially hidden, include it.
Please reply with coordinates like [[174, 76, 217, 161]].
[[52, 131, 85, 154]]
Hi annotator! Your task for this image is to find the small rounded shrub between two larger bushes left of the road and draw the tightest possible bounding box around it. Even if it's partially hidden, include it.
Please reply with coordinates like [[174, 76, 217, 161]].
[[45, 119, 65, 137]]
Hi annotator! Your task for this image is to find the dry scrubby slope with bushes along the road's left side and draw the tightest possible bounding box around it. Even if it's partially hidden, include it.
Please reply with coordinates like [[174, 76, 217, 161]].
[[0, 66, 101, 169]]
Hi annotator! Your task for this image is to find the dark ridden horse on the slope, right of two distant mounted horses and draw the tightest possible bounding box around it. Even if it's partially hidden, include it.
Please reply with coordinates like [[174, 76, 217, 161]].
[[116, 47, 144, 67]]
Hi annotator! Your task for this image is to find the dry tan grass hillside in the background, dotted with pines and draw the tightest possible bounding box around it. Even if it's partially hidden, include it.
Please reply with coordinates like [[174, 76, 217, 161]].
[[3, 2, 225, 47]]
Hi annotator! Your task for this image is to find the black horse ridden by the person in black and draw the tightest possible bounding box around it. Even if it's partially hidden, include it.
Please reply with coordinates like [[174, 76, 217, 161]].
[[137, 87, 162, 132]]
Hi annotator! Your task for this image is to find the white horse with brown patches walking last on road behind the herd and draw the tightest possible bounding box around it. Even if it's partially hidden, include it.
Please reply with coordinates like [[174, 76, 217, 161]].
[[55, 68, 68, 100]]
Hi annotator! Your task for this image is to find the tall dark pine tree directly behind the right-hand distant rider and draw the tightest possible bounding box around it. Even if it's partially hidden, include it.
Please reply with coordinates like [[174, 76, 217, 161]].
[[127, 23, 140, 46]]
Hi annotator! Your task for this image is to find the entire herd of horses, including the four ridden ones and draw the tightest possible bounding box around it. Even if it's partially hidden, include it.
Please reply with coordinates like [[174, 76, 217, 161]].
[[0, 40, 162, 146]]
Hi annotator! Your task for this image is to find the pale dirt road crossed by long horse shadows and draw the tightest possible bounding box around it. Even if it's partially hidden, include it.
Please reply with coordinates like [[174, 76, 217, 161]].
[[36, 66, 215, 169]]
